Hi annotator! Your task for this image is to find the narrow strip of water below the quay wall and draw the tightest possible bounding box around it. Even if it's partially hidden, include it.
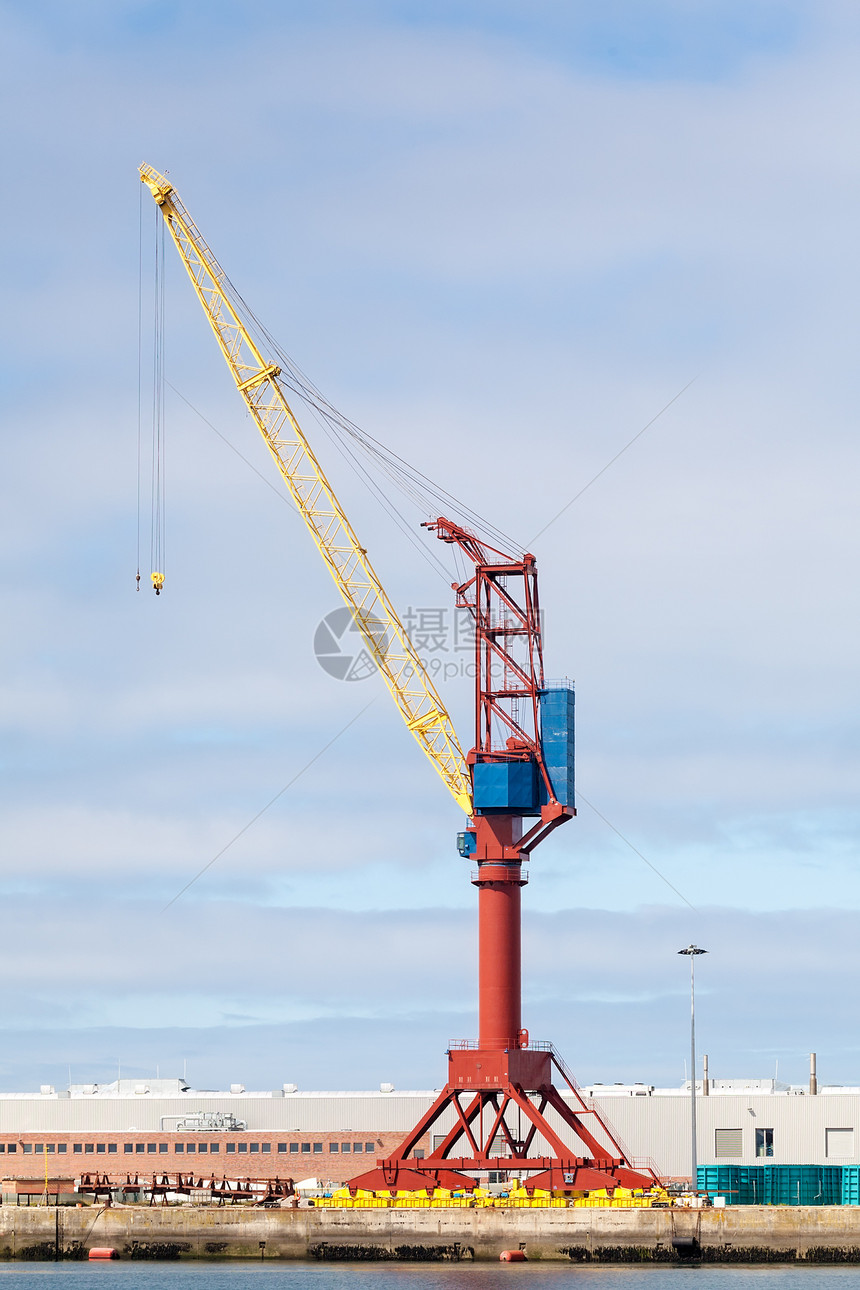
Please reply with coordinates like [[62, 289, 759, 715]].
[[0, 1263, 860, 1290]]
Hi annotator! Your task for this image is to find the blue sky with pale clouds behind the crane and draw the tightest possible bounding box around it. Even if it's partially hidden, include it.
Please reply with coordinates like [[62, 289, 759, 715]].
[[0, 0, 860, 1090]]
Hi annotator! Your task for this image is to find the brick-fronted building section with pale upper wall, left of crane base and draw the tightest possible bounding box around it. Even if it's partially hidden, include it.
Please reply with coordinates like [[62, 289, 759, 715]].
[[0, 1080, 433, 1183]]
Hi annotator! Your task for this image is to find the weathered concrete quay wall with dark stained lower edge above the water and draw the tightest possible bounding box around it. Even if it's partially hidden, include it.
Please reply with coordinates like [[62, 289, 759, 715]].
[[6, 1205, 860, 1263]]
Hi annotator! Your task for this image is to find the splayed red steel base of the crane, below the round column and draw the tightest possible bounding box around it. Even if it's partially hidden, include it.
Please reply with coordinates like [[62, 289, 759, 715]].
[[347, 1045, 658, 1196]]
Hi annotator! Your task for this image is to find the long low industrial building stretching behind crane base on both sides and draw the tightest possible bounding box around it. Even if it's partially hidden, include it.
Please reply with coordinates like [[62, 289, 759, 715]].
[[0, 1078, 860, 1183]]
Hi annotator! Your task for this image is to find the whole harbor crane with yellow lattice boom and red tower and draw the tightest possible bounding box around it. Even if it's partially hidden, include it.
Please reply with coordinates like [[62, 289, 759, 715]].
[[139, 165, 655, 1195]]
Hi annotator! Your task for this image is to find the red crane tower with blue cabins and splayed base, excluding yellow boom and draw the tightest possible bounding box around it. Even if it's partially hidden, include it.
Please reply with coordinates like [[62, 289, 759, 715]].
[[349, 519, 655, 1193]]
